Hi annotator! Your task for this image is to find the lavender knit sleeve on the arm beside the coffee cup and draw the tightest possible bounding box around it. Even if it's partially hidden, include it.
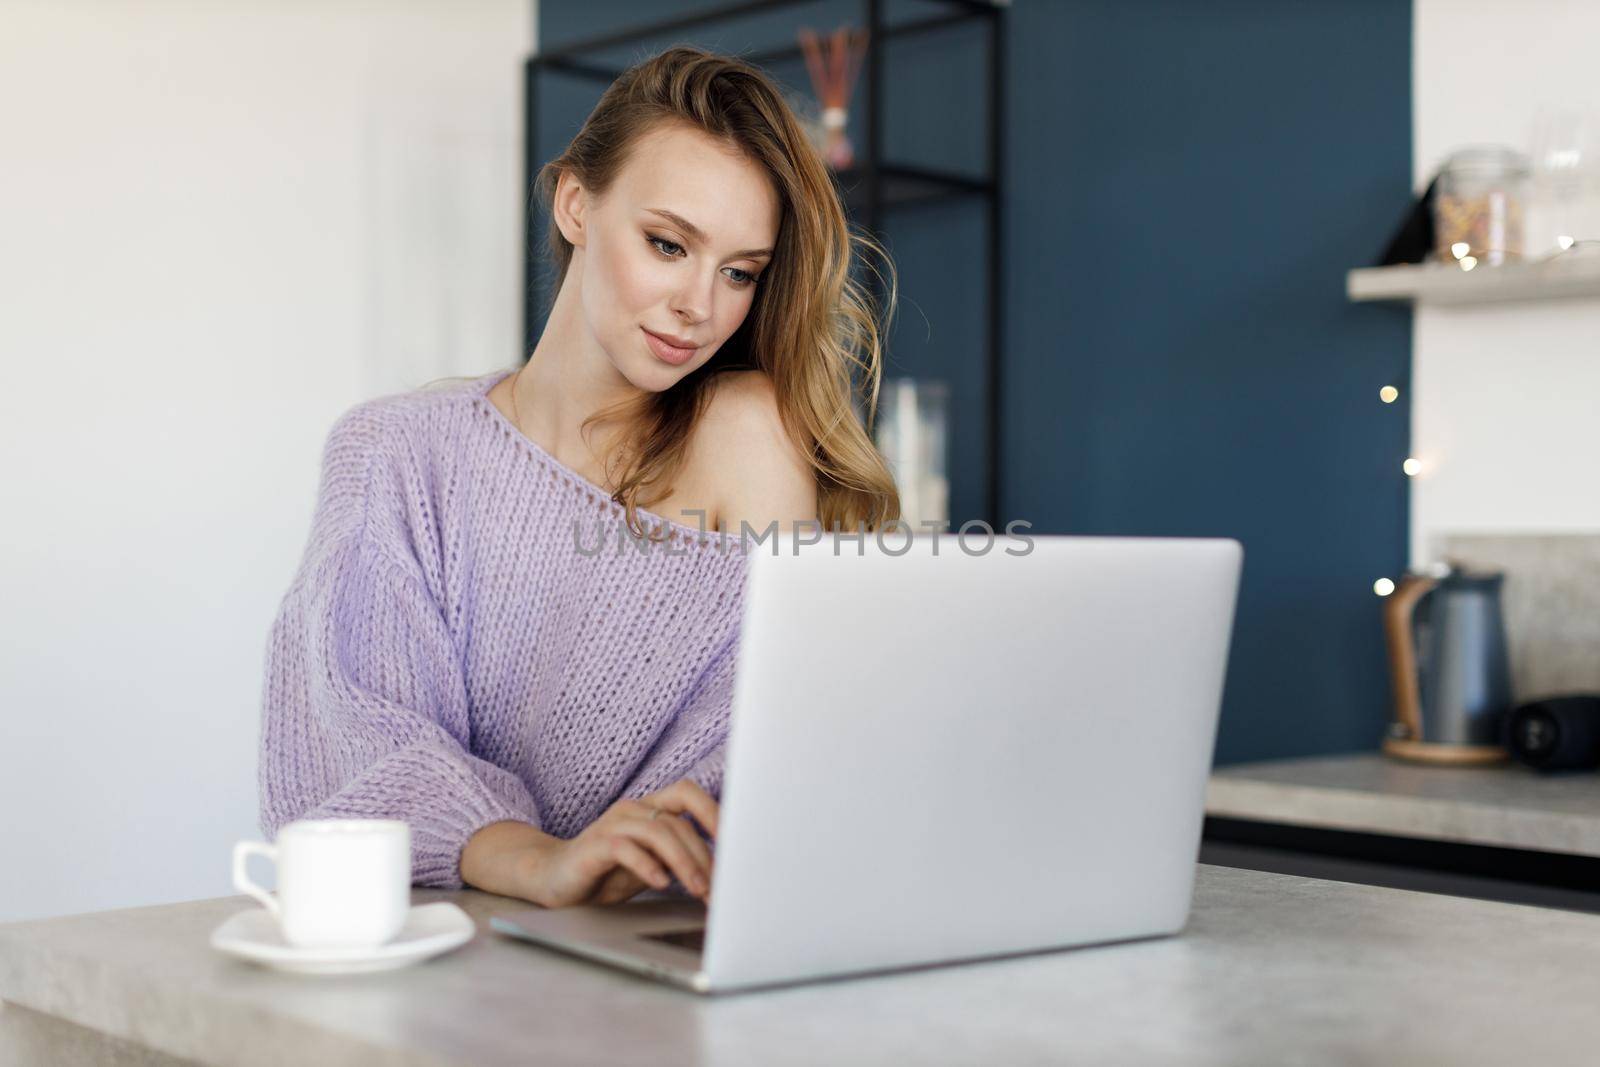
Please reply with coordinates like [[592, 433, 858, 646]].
[[259, 409, 541, 889]]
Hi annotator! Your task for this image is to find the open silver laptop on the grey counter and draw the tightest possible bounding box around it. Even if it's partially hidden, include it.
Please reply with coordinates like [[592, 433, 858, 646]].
[[491, 533, 1243, 993]]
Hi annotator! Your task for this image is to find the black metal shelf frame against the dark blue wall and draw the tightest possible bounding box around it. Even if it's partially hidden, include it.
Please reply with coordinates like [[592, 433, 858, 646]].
[[518, 0, 1006, 531]]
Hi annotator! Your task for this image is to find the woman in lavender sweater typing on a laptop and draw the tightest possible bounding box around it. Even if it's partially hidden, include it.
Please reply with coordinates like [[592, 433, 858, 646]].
[[261, 48, 899, 907]]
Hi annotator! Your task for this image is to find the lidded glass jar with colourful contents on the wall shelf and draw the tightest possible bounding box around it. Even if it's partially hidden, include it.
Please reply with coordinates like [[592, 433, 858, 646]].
[[1434, 146, 1528, 270]]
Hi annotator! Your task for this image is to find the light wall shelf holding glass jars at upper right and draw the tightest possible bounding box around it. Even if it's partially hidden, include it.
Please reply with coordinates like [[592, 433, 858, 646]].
[[1344, 251, 1600, 304]]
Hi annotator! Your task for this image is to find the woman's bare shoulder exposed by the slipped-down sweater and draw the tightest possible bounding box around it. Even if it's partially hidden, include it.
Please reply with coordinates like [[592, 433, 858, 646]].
[[696, 370, 816, 533]]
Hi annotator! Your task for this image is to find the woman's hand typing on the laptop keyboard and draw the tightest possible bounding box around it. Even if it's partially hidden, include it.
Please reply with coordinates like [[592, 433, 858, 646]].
[[523, 779, 717, 907]]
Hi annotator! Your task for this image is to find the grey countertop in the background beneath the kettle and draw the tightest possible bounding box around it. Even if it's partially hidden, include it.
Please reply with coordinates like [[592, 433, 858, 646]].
[[1206, 753, 1600, 856]]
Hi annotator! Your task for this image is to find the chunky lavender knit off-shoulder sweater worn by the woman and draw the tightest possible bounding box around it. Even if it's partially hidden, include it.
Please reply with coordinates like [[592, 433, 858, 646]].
[[259, 370, 747, 889]]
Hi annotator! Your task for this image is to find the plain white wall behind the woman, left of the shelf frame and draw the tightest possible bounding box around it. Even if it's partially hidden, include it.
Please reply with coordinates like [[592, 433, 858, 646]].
[[0, 0, 534, 921]]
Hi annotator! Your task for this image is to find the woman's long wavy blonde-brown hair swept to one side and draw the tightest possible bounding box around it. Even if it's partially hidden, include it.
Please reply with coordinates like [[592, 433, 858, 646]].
[[476, 45, 901, 536]]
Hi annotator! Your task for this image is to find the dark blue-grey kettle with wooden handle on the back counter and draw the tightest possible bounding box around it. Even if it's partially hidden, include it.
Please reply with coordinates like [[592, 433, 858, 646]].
[[1382, 565, 1512, 763]]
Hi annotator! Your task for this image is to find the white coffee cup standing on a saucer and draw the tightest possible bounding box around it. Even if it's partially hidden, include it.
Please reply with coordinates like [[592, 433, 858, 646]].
[[234, 819, 411, 949]]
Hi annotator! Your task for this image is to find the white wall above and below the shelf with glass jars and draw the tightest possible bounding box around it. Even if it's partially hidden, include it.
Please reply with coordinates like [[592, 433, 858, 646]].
[[1411, 0, 1600, 565]]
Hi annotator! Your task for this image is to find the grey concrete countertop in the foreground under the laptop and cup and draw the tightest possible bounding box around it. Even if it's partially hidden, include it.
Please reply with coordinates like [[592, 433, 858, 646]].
[[0, 865, 1600, 1067]]
